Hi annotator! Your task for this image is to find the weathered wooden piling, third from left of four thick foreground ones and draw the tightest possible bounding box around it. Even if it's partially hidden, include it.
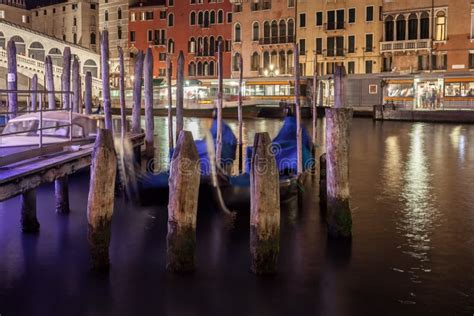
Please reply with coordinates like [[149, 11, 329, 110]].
[[250, 133, 280, 274]]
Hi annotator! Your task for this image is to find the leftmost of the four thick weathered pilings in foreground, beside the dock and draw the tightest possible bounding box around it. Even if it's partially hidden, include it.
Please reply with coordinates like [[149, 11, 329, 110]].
[[87, 129, 117, 270]]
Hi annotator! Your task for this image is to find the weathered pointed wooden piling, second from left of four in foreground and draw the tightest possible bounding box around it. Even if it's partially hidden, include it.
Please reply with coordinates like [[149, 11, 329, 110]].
[[166, 131, 200, 272]]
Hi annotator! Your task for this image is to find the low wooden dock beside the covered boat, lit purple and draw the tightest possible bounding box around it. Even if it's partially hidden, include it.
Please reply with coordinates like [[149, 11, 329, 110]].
[[0, 133, 145, 201]]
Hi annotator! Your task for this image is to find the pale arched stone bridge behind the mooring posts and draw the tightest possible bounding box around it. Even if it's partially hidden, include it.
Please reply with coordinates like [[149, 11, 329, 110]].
[[0, 19, 102, 96]]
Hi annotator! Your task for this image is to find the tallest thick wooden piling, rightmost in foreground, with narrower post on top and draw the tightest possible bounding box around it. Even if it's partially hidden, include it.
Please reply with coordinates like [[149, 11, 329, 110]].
[[326, 66, 353, 238]]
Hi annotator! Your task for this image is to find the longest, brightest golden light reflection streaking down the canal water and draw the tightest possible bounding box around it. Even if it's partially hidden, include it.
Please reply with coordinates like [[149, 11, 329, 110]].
[[397, 124, 439, 282]]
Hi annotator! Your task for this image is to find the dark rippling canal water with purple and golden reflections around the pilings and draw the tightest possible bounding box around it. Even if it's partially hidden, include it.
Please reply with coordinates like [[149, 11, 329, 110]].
[[0, 118, 474, 316]]
